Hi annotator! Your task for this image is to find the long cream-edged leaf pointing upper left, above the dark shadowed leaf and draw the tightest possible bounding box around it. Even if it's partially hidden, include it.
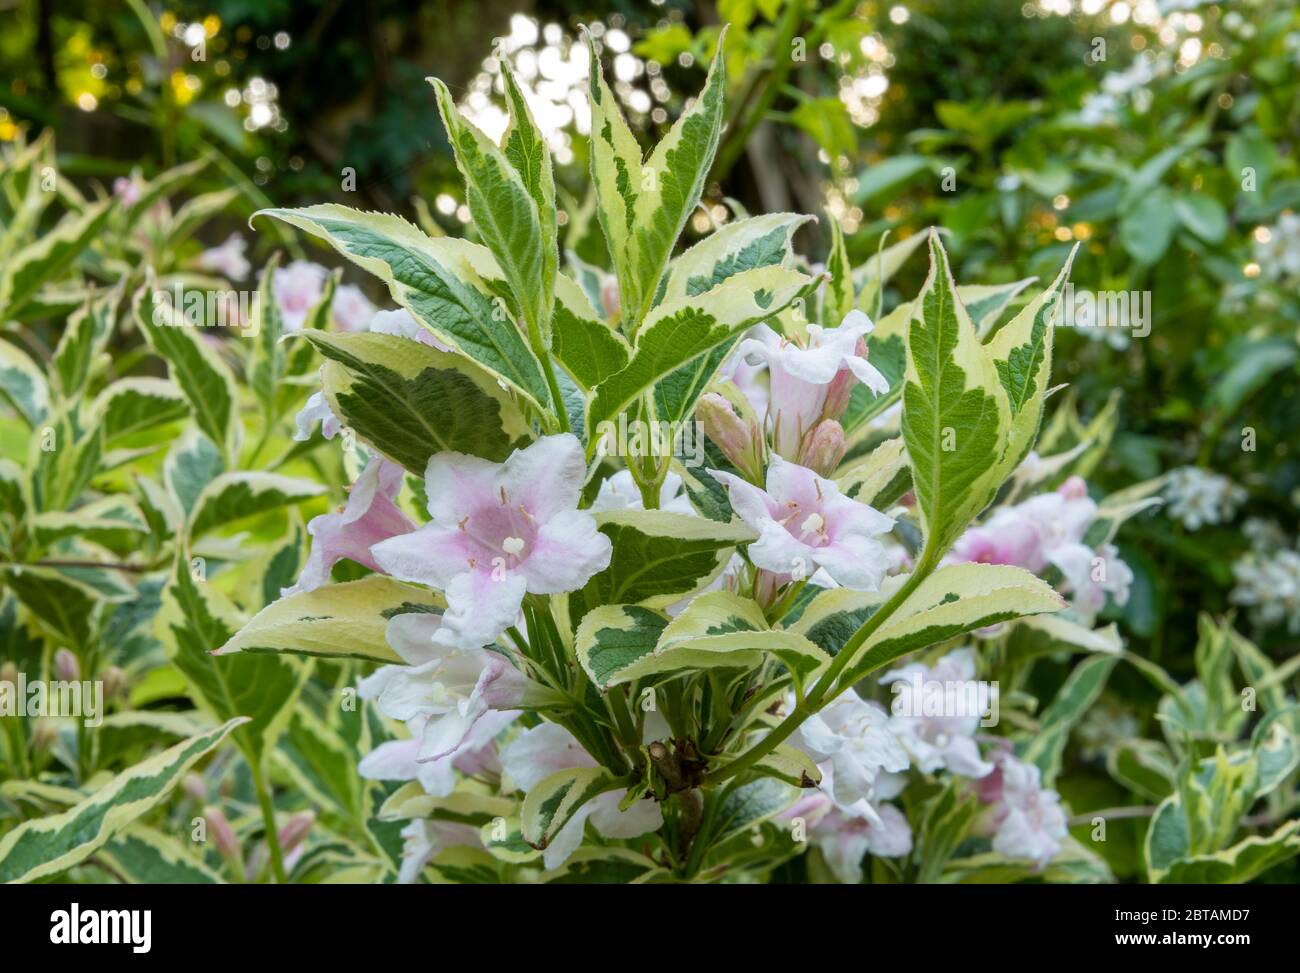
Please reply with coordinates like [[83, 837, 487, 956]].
[[257, 204, 550, 410]]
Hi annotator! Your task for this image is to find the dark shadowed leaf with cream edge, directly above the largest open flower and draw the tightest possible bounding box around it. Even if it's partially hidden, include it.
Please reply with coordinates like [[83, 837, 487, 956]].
[[303, 332, 529, 476]]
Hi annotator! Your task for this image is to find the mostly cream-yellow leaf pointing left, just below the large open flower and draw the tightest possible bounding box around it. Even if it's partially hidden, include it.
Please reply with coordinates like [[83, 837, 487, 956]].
[[212, 575, 443, 663]]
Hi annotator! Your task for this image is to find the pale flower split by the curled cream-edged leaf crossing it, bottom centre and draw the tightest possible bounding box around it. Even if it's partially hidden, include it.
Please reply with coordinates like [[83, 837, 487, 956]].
[[501, 723, 663, 869]]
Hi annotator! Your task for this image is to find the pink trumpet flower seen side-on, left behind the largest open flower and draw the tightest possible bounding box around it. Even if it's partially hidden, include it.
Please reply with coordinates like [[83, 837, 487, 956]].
[[281, 455, 415, 594]]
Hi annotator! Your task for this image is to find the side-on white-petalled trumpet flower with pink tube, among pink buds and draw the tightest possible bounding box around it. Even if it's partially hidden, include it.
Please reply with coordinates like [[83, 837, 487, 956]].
[[737, 311, 889, 459]]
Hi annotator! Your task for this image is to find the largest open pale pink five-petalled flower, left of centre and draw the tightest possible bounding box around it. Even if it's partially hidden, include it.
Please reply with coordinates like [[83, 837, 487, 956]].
[[372, 433, 611, 648]]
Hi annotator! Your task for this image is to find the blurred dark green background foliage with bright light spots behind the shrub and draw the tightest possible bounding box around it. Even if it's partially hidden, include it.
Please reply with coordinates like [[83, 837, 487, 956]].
[[0, 0, 1300, 879]]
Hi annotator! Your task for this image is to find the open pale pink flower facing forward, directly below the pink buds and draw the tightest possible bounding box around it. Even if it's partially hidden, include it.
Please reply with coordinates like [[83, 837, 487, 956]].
[[709, 455, 893, 591]]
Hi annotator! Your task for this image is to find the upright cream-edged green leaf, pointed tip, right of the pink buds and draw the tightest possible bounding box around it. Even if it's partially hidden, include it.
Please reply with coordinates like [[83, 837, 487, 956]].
[[902, 233, 1011, 558]]
